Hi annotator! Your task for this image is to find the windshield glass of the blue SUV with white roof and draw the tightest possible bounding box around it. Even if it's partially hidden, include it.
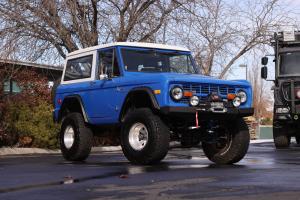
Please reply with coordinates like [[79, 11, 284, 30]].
[[121, 49, 196, 74]]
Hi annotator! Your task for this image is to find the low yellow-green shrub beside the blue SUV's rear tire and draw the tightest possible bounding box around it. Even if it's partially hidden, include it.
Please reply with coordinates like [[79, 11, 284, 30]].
[[5, 101, 59, 149]]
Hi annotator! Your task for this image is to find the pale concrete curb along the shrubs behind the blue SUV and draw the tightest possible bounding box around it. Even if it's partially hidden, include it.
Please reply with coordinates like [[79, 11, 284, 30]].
[[0, 146, 121, 156]]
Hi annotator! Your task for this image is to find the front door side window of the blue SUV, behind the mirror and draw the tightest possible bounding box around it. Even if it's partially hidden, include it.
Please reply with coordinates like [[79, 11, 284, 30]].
[[99, 49, 120, 78]]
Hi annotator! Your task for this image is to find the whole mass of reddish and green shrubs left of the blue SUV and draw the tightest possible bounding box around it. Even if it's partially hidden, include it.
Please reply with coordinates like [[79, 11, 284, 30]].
[[0, 67, 58, 148]]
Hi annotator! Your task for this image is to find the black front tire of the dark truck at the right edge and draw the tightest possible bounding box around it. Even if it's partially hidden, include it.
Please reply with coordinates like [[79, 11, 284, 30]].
[[273, 123, 291, 149]]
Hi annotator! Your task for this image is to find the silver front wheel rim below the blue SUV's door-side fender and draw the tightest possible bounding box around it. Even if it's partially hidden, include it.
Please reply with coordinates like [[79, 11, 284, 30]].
[[128, 122, 148, 151]]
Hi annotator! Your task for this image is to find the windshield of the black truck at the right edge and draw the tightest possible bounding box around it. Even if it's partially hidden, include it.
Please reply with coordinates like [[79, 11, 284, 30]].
[[280, 52, 300, 75]]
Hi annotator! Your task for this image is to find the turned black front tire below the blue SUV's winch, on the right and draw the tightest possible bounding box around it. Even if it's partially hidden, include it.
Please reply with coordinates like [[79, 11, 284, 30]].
[[202, 118, 250, 164]]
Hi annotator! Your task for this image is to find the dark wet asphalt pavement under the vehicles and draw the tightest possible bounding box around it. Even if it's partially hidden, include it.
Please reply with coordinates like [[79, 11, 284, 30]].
[[0, 143, 300, 200]]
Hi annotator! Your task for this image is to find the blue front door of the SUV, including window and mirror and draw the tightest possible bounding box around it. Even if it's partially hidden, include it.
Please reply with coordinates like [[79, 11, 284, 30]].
[[86, 48, 122, 124]]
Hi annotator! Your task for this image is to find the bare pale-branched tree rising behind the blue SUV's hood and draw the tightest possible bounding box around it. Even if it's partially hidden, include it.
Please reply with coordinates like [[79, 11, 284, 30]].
[[172, 0, 292, 78]]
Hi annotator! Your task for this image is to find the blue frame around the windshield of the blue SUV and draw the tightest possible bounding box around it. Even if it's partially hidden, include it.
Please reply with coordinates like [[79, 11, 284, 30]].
[[119, 46, 200, 74]]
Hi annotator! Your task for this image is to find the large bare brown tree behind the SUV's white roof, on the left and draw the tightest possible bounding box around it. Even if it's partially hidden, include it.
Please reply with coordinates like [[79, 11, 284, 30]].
[[0, 0, 183, 60]]
